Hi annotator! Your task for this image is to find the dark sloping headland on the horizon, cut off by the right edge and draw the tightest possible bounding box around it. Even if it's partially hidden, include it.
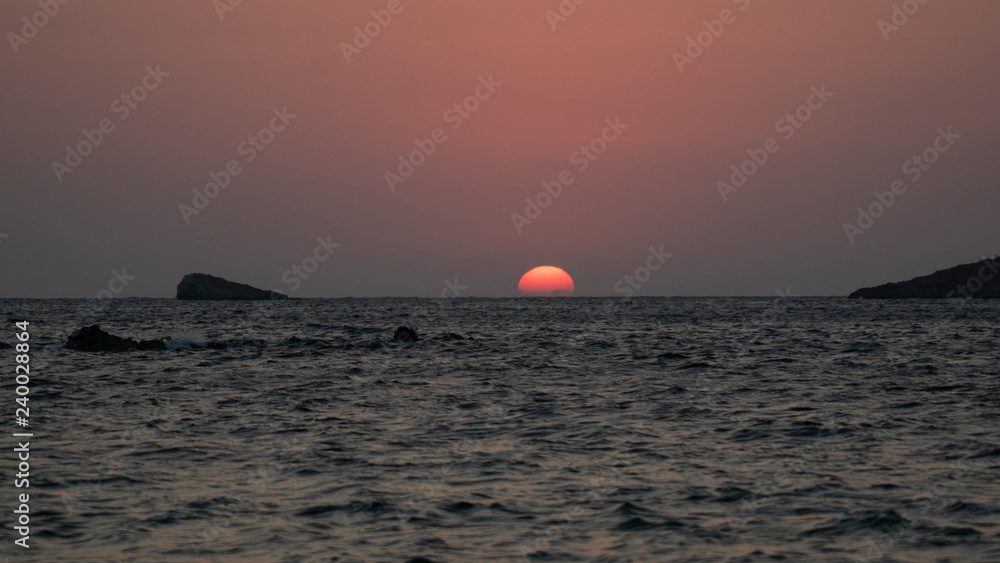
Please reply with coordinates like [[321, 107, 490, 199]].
[[850, 256, 1000, 299]]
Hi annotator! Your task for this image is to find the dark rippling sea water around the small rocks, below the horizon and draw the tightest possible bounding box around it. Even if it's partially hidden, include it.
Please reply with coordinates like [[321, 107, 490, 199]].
[[0, 297, 1000, 562]]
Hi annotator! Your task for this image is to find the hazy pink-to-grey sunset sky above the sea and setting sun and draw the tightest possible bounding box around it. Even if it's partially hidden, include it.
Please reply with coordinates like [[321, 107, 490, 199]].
[[0, 0, 1000, 298]]
